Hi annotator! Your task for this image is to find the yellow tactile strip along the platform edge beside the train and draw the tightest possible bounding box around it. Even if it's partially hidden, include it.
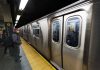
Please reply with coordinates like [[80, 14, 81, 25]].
[[21, 38, 56, 70]]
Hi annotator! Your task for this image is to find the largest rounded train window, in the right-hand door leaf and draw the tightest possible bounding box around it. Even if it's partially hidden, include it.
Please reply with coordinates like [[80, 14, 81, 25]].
[[66, 16, 81, 47]]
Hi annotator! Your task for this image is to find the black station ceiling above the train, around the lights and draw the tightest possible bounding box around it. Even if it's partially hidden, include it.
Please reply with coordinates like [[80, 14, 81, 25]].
[[7, 0, 78, 27]]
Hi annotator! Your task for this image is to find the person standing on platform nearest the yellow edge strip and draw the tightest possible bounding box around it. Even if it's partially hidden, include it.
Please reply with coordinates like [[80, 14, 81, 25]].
[[12, 29, 21, 62]]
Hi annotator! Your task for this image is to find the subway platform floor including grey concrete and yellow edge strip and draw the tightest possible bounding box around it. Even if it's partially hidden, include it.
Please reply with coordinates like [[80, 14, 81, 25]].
[[0, 38, 56, 70]]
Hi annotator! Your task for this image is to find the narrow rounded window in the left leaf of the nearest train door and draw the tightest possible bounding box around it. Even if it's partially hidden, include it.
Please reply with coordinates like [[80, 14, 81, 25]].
[[52, 20, 60, 42]]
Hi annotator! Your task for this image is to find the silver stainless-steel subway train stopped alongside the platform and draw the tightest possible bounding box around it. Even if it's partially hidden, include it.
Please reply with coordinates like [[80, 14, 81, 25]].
[[19, 0, 100, 70]]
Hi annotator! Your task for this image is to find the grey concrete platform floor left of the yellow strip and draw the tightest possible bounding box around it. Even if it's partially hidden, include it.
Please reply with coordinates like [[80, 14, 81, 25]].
[[0, 46, 32, 70]]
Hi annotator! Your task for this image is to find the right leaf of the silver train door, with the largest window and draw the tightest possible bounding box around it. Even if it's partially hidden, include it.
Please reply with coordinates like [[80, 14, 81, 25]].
[[63, 11, 87, 70]]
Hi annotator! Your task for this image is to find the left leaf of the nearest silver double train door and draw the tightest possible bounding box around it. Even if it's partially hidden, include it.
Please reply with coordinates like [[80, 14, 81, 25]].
[[51, 16, 63, 67]]
